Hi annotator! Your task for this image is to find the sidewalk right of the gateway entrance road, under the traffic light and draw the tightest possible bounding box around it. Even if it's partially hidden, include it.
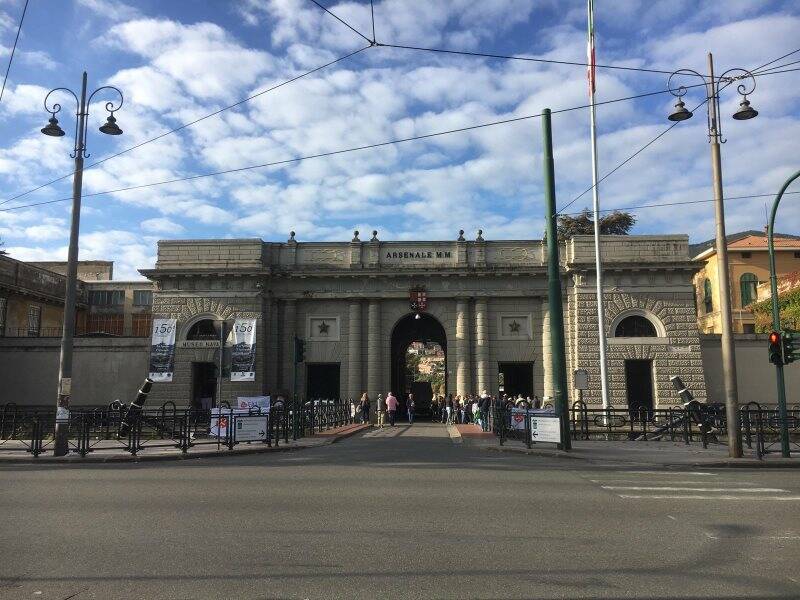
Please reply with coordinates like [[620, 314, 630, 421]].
[[448, 425, 800, 468]]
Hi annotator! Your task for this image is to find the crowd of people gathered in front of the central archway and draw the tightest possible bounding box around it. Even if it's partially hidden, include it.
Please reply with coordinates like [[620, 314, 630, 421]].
[[351, 390, 542, 431]]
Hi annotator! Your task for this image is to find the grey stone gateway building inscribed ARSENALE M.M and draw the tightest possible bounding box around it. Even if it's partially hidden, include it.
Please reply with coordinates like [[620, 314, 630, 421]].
[[141, 232, 706, 408]]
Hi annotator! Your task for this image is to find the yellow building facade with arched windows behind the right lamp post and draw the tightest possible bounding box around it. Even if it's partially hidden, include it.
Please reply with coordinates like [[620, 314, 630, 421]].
[[691, 231, 800, 333]]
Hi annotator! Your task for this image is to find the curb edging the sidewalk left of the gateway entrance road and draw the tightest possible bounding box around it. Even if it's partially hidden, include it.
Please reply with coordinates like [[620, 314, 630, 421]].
[[0, 427, 367, 467]]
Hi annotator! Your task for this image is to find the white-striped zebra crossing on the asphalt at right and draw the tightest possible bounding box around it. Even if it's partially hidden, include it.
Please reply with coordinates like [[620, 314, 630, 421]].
[[589, 471, 800, 502]]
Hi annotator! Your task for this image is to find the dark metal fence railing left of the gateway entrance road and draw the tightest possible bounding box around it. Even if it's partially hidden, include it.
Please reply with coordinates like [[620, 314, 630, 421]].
[[0, 400, 353, 456]]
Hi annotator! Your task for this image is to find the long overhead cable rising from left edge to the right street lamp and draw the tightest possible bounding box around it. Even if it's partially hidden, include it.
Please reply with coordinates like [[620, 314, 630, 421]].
[[0, 78, 720, 212]]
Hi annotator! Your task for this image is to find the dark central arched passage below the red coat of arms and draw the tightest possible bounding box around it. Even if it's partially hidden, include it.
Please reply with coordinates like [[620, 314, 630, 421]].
[[391, 313, 447, 415]]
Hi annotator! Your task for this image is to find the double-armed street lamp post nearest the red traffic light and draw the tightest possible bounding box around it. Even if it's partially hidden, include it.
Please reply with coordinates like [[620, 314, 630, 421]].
[[668, 53, 758, 458]]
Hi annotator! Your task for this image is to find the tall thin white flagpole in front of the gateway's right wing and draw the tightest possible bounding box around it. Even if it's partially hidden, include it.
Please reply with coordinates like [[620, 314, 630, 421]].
[[587, 0, 611, 409]]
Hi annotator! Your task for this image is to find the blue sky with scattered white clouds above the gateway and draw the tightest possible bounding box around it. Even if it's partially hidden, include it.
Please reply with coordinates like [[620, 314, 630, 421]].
[[0, 0, 800, 279]]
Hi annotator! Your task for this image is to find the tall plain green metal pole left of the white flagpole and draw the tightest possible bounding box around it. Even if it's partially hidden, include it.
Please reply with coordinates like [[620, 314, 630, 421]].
[[542, 108, 571, 450]]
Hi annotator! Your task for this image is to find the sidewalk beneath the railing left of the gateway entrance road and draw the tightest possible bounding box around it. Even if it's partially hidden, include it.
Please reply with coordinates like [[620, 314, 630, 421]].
[[0, 423, 370, 465]]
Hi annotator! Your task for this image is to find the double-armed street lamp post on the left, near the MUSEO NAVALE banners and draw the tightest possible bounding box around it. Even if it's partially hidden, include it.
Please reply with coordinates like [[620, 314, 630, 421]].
[[42, 71, 124, 456]]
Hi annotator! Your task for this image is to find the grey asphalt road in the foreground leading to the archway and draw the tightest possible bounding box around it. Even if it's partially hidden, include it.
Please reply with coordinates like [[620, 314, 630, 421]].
[[0, 424, 800, 600]]
